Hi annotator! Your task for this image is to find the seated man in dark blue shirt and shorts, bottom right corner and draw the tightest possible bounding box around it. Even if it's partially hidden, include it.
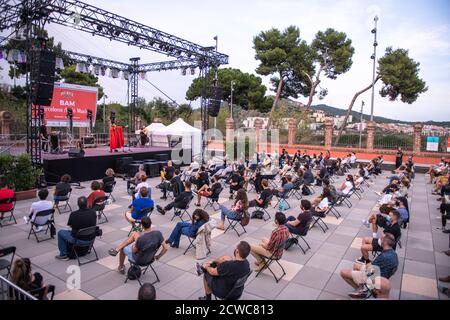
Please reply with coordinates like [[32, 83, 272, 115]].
[[341, 233, 398, 299]]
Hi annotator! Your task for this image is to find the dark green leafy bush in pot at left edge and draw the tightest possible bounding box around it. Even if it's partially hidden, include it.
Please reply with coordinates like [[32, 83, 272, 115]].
[[0, 154, 42, 200]]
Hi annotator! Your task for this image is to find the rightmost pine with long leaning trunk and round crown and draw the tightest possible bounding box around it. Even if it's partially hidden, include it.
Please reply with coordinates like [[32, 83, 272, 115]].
[[335, 47, 428, 145]]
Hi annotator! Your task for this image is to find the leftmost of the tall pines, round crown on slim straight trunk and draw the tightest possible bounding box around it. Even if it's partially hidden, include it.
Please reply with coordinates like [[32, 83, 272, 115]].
[[253, 26, 314, 126]]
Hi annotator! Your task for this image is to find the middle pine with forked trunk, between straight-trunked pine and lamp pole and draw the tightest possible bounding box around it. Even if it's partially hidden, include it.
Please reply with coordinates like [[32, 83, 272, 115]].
[[304, 28, 355, 109]]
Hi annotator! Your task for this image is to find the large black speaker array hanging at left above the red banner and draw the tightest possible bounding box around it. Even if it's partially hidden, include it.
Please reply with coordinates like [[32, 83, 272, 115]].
[[31, 50, 56, 106]]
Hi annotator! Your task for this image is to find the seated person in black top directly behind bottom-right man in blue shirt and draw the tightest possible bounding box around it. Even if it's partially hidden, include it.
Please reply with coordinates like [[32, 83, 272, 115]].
[[357, 208, 401, 263]]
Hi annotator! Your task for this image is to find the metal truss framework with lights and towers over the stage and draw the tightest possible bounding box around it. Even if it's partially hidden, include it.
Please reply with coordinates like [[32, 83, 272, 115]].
[[0, 0, 228, 164]]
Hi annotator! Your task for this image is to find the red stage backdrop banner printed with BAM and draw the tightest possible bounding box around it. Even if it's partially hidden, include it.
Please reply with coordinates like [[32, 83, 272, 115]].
[[38, 83, 98, 128]]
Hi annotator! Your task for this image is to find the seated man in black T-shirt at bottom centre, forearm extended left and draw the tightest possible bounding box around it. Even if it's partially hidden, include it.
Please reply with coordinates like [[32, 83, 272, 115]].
[[197, 241, 250, 300]]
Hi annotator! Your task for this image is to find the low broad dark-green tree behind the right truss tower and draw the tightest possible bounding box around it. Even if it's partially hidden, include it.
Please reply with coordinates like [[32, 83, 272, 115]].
[[186, 68, 267, 110]]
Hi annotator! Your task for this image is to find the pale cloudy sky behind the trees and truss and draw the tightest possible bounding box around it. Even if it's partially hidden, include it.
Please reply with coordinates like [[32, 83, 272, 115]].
[[1, 0, 450, 121]]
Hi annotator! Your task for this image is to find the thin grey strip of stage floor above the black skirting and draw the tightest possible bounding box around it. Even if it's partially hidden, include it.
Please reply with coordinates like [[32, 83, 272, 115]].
[[42, 146, 171, 160]]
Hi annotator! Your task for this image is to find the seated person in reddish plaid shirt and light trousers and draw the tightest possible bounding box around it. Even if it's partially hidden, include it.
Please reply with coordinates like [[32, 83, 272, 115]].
[[250, 212, 289, 271]]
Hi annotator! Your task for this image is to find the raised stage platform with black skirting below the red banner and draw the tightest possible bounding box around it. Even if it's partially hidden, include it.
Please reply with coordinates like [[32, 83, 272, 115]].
[[42, 147, 178, 183]]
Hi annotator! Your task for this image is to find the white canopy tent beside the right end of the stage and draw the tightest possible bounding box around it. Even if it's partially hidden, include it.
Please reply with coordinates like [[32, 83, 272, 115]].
[[152, 118, 202, 156]]
